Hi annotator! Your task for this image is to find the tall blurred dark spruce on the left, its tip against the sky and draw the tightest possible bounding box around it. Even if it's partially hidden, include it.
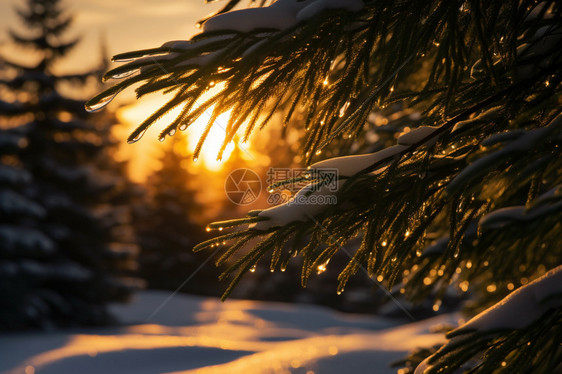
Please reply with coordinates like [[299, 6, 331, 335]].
[[0, 0, 136, 329]]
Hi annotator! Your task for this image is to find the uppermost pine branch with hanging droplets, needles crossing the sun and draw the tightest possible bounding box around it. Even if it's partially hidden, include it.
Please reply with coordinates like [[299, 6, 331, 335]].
[[89, 1, 560, 160]]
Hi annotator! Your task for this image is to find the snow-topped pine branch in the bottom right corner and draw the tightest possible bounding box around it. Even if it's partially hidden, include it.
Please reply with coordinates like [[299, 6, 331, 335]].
[[415, 265, 562, 374]]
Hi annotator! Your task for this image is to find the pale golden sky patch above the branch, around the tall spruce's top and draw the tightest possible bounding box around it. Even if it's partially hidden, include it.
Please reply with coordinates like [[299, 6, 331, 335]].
[[0, 0, 221, 75]]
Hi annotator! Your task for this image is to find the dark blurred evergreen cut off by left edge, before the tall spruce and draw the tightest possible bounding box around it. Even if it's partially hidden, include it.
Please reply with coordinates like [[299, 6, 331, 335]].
[[0, 118, 56, 329]]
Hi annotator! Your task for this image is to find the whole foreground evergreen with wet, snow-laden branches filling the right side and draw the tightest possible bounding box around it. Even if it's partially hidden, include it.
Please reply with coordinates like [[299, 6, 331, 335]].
[[88, 0, 562, 373]]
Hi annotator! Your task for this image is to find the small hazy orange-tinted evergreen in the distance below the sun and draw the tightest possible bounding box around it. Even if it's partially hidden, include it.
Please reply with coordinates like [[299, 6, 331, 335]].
[[135, 136, 220, 295]]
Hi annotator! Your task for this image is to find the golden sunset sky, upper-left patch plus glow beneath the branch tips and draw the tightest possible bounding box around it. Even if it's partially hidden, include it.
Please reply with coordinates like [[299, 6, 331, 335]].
[[0, 0, 236, 181]]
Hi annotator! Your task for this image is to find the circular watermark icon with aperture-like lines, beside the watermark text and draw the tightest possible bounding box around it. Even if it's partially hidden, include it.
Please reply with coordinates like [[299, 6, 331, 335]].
[[224, 169, 261, 205]]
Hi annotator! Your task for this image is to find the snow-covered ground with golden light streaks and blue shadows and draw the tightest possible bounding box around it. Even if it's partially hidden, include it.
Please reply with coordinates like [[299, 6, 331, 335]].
[[0, 291, 454, 374]]
